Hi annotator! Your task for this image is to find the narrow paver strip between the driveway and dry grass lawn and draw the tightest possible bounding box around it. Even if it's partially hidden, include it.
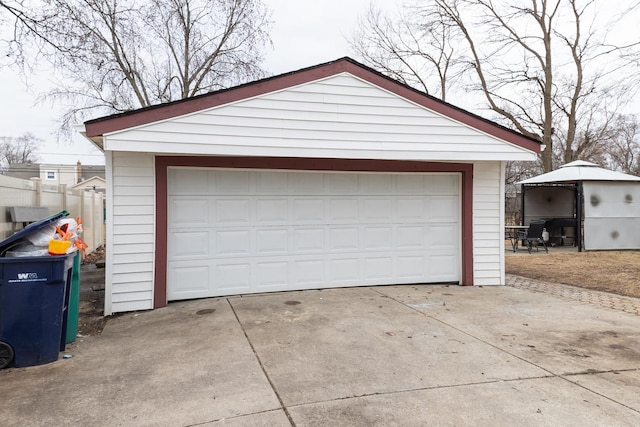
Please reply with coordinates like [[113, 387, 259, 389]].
[[506, 274, 640, 316]]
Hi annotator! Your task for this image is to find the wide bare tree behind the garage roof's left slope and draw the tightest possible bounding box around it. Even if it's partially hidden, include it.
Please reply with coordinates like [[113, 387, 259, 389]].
[[0, 0, 271, 132]]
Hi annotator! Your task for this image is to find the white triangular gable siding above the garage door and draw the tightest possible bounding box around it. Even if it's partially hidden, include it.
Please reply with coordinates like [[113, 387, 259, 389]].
[[104, 74, 532, 162]]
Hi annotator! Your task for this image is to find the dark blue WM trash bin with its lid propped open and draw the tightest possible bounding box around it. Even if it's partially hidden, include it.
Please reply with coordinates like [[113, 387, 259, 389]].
[[0, 211, 75, 369]]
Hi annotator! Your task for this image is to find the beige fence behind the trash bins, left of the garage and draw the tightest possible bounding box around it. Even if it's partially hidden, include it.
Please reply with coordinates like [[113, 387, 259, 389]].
[[0, 175, 105, 253]]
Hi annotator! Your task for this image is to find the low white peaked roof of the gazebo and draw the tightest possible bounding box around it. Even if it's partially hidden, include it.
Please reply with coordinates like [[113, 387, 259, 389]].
[[518, 160, 640, 184]]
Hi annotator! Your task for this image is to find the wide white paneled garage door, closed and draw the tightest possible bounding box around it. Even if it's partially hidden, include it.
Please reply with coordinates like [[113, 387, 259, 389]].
[[167, 168, 460, 300]]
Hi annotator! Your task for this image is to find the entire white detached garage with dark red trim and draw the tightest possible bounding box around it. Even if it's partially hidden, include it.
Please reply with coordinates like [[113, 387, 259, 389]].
[[80, 58, 540, 315]]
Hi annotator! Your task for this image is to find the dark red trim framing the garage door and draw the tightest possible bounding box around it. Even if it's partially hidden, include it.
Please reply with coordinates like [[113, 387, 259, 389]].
[[153, 156, 473, 308]]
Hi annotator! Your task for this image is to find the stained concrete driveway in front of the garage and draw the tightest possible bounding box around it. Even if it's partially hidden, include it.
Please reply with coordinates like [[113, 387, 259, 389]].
[[0, 285, 640, 426]]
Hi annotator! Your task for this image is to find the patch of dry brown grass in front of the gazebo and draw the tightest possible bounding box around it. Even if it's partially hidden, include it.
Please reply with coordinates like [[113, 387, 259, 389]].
[[505, 249, 640, 298]]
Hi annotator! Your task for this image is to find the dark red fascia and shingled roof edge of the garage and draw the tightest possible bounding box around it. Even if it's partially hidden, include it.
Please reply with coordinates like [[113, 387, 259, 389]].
[[84, 57, 541, 153]]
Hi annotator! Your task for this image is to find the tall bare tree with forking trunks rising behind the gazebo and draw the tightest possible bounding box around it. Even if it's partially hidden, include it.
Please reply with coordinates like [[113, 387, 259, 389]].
[[435, 0, 640, 171]]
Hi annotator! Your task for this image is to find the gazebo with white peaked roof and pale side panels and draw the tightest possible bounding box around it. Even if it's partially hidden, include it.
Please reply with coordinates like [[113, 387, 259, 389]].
[[519, 160, 640, 250]]
